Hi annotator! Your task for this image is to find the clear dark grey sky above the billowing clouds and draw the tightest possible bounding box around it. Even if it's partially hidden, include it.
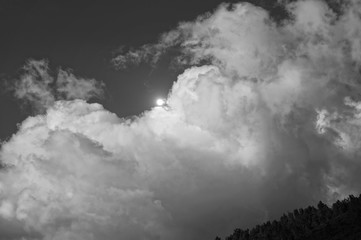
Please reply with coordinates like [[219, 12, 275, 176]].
[[0, 0, 284, 140]]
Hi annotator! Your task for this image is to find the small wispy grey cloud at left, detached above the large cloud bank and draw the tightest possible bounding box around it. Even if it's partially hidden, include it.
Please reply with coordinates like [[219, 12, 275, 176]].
[[11, 59, 104, 112]]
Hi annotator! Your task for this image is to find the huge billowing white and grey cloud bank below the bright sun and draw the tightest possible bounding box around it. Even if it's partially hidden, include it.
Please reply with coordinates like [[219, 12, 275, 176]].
[[0, 0, 361, 240]]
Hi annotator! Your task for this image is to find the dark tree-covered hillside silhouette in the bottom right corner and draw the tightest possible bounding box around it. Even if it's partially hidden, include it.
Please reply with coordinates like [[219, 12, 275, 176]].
[[216, 194, 361, 240]]
